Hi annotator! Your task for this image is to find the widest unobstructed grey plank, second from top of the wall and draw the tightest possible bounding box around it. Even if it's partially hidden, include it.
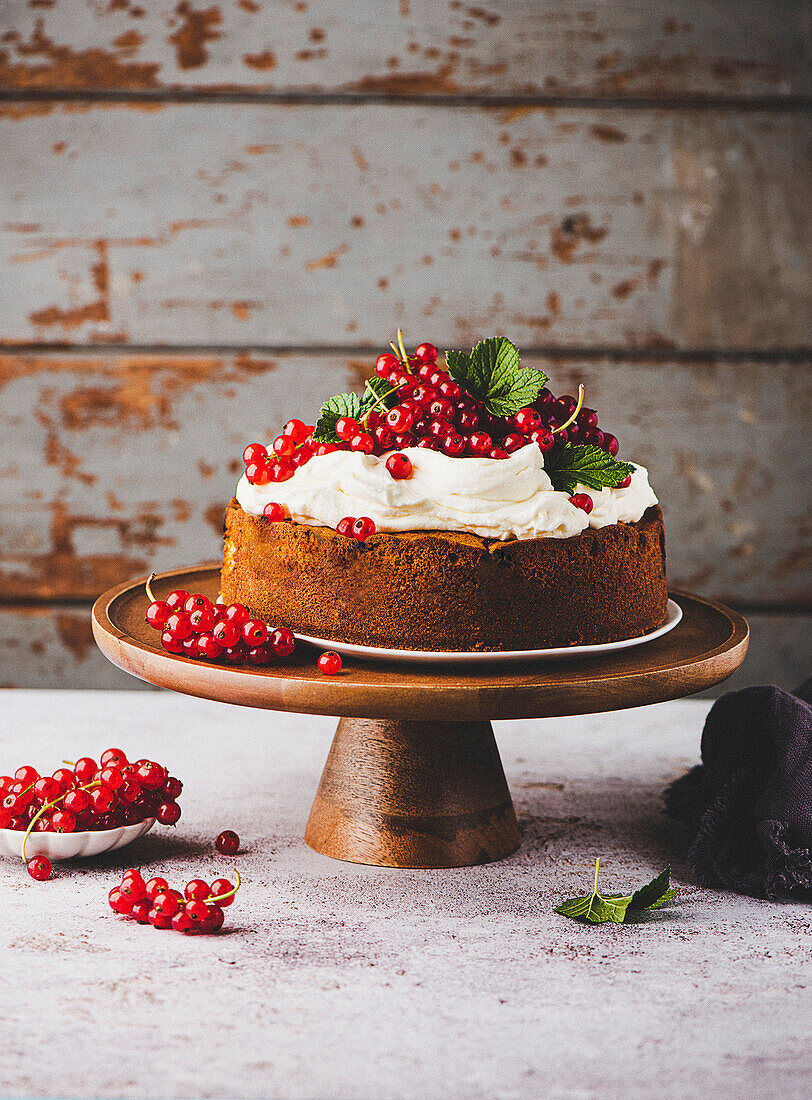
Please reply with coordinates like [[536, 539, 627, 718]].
[[0, 103, 812, 350]]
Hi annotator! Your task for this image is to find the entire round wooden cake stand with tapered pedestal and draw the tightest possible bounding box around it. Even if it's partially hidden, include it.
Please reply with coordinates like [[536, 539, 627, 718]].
[[92, 565, 748, 867]]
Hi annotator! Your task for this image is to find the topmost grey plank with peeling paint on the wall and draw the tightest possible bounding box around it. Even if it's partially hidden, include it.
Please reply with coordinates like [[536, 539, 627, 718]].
[[0, 0, 809, 98]]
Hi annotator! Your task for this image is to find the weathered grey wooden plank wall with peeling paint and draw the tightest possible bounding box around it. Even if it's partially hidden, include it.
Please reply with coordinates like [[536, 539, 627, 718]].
[[0, 0, 812, 685]]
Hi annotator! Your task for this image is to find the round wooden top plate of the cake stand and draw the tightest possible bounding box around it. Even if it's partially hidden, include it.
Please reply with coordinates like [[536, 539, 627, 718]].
[[91, 565, 749, 722]]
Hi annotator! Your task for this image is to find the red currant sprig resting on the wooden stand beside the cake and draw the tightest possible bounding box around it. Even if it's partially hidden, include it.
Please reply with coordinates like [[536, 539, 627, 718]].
[[146, 573, 296, 666]]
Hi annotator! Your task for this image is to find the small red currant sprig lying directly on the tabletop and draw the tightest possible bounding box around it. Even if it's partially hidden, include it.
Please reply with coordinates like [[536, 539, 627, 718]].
[[108, 870, 240, 933]]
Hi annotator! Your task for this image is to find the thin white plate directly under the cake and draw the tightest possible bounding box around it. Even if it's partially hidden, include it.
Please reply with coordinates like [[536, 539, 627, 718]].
[[296, 600, 682, 664]]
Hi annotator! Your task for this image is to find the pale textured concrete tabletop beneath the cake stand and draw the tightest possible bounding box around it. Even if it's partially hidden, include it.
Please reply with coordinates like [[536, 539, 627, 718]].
[[0, 691, 812, 1100]]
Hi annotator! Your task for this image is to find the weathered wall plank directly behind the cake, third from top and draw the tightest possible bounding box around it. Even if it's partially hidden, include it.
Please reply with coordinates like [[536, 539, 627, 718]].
[[0, 352, 812, 606]]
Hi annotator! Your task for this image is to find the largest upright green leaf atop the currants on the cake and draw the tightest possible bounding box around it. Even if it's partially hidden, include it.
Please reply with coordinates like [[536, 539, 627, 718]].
[[446, 337, 547, 416]]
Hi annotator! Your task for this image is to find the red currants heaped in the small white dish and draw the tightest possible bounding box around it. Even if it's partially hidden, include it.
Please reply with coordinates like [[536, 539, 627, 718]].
[[0, 749, 184, 840]]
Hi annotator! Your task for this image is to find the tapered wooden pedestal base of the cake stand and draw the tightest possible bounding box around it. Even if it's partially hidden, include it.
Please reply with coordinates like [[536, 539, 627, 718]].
[[305, 718, 519, 867]]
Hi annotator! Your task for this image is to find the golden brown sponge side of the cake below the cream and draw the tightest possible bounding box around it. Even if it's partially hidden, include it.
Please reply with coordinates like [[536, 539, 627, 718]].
[[222, 498, 668, 650]]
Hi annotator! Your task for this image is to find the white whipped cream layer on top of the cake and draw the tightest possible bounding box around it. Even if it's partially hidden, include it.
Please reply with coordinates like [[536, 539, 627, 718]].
[[237, 446, 657, 540]]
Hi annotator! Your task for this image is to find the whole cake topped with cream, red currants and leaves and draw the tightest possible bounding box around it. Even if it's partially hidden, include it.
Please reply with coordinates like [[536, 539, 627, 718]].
[[221, 338, 668, 651]]
